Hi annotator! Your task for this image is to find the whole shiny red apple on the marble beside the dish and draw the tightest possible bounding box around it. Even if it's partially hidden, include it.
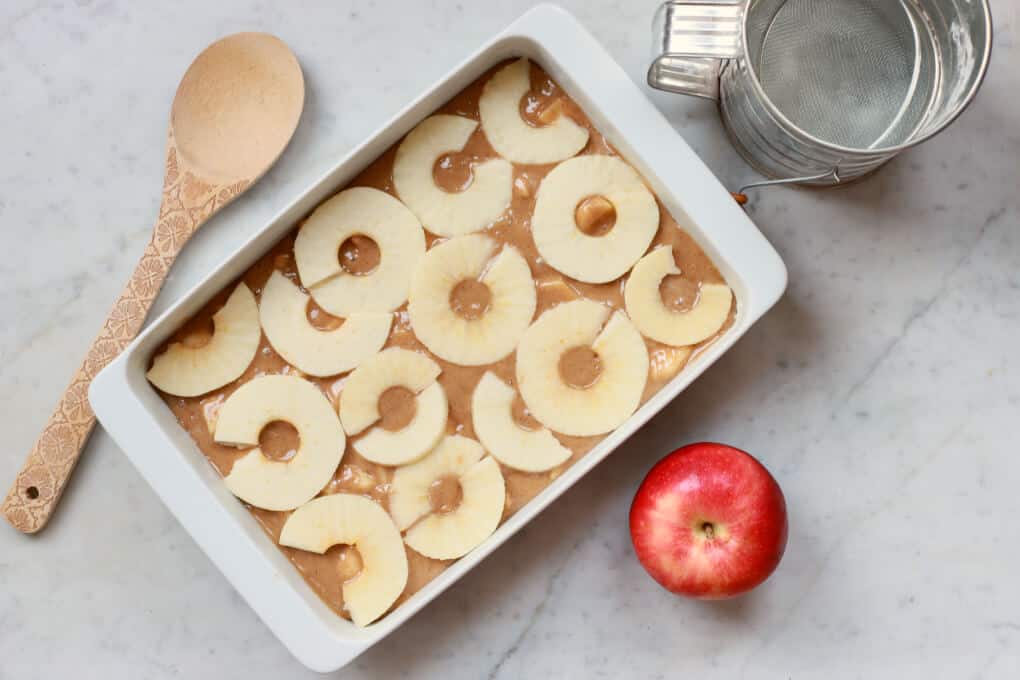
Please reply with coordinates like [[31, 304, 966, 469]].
[[630, 443, 786, 599]]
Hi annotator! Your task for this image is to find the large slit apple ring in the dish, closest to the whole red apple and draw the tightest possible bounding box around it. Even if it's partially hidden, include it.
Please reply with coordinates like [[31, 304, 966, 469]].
[[516, 298, 649, 436]]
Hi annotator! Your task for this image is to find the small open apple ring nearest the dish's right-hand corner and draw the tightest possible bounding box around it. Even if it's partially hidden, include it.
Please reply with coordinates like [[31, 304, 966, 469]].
[[623, 246, 733, 347]]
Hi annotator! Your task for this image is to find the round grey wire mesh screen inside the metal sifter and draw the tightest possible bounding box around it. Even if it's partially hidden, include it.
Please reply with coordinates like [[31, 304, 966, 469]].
[[748, 0, 931, 149]]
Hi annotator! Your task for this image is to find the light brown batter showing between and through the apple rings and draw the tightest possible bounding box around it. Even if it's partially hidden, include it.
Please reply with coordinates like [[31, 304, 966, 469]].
[[150, 62, 733, 618]]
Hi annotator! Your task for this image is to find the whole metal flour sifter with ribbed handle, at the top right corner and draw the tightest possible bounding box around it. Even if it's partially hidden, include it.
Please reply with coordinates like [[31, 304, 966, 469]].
[[648, 0, 991, 192]]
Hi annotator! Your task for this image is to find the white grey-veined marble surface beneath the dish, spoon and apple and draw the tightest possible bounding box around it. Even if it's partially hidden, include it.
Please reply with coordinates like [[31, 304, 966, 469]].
[[0, 0, 1020, 680]]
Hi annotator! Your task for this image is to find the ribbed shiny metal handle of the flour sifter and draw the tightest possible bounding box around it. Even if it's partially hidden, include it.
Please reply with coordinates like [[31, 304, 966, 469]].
[[648, 0, 745, 100]]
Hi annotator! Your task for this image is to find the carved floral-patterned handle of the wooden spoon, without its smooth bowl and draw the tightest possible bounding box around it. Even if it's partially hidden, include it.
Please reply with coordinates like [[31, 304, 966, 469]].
[[0, 133, 251, 533]]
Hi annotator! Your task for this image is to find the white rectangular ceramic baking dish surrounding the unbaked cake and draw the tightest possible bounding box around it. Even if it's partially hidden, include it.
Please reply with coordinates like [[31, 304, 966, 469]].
[[90, 5, 786, 672]]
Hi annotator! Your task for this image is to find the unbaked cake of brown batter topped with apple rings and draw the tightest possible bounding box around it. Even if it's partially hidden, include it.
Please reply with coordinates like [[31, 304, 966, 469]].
[[148, 59, 735, 625]]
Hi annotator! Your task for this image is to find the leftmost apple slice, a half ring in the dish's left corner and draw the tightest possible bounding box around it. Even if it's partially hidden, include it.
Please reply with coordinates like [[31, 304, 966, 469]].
[[146, 283, 262, 397]]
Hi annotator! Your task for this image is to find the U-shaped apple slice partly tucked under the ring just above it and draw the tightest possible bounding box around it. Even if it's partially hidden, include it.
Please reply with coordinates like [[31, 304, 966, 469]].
[[259, 271, 393, 377]]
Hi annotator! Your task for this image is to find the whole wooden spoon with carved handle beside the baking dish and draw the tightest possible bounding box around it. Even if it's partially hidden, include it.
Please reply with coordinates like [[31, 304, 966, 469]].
[[0, 33, 305, 533]]
